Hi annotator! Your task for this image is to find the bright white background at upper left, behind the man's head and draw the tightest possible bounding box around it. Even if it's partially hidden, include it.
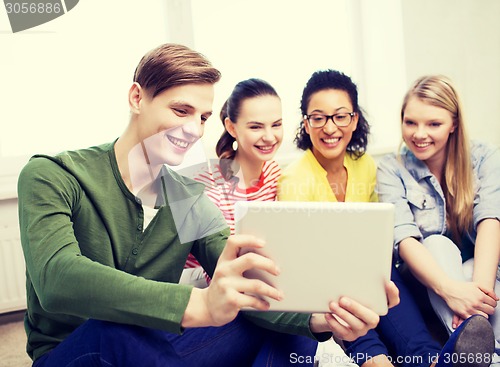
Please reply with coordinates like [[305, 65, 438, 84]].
[[0, 0, 169, 198]]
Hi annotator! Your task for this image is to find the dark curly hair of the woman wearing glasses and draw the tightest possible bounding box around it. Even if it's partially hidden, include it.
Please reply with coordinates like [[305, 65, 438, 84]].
[[293, 69, 370, 159]]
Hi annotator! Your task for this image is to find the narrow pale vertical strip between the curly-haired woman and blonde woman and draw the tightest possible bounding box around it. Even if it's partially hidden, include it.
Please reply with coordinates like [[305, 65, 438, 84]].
[[349, 0, 407, 155]]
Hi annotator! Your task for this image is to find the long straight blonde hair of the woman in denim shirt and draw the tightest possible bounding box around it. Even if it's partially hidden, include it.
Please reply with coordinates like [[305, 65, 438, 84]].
[[401, 75, 474, 245]]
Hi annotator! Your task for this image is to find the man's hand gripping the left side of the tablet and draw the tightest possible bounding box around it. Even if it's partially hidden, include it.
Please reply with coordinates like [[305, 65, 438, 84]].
[[182, 235, 283, 327]]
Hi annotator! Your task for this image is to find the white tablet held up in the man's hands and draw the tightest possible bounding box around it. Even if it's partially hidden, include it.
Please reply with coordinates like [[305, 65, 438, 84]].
[[235, 201, 394, 315]]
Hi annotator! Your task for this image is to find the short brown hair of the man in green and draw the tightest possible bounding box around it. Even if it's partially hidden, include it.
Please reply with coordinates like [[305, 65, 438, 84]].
[[134, 43, 221, 98]]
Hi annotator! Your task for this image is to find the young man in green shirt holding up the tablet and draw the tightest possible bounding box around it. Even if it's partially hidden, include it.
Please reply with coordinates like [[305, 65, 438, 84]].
[[18, 44, 398, 367]]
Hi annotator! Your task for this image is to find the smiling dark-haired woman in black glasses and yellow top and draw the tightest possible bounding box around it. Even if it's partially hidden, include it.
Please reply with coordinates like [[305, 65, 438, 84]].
[[279, 70, 376, 201]]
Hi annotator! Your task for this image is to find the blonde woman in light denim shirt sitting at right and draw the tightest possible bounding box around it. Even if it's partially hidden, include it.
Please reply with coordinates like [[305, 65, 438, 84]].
[[377, 75, 500, 365]]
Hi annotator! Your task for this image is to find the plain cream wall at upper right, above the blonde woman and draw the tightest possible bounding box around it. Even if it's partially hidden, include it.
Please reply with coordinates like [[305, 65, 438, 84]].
[[402, 0, 500, 146]]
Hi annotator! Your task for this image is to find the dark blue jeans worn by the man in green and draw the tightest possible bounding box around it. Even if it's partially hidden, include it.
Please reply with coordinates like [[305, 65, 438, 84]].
[[33, 316, 317, 367]]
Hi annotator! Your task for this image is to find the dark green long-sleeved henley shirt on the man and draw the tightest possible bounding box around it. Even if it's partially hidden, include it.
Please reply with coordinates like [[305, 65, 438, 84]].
[[18, 143, 320, 359]]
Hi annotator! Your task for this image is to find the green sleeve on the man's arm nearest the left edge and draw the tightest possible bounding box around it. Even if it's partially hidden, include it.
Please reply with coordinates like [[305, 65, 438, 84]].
[[18, 159, 192, 333]]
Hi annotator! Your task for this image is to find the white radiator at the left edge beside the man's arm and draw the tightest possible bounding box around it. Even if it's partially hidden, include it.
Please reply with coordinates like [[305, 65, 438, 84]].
[[0, 225, 26, 314]]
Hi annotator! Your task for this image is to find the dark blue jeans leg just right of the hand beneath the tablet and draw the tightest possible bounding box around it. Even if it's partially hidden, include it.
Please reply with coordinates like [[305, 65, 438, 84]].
[[344, 267, 441, 367]]
